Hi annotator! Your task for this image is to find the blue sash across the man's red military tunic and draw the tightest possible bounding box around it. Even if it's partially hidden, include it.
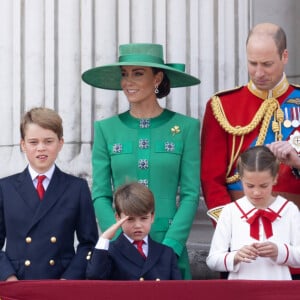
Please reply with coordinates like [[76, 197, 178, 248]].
[[227, 89, 300, 191]]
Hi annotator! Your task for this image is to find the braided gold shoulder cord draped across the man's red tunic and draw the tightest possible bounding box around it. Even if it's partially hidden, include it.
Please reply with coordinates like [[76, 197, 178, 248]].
[[211, 96, 284, 183]]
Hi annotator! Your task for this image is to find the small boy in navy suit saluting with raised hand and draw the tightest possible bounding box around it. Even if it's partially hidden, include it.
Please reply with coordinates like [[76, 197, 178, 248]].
[[87, 182, 182, 280]]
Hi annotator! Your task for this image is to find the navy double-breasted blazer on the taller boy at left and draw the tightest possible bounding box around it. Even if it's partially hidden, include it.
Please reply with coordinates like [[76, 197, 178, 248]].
[[0, 167, 98, 280]]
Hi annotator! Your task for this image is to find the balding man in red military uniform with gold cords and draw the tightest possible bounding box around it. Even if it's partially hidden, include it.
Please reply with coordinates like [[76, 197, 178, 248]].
[[201, 23, 300, 278]]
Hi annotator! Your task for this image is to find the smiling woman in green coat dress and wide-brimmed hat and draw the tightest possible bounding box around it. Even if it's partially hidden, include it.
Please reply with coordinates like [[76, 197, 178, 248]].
[[82, 44, 200, 279]]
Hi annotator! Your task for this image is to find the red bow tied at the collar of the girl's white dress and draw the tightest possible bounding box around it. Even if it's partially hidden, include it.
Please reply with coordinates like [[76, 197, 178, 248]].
[[247, 209, 278, 240]]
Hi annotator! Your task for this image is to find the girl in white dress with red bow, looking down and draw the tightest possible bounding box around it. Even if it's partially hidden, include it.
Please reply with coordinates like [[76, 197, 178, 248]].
[[206, 146, 300, 280]]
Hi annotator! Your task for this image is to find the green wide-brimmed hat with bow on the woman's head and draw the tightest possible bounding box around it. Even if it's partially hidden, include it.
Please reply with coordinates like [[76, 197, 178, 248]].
[[82, 43, 200, 90]]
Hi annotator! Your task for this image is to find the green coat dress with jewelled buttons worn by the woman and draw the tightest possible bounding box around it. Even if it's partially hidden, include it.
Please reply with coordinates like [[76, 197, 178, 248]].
[[92, 109, 200, 279]]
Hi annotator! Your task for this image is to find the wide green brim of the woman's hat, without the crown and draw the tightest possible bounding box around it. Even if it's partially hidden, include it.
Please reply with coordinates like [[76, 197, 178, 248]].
[[82, 62, 200, 90]]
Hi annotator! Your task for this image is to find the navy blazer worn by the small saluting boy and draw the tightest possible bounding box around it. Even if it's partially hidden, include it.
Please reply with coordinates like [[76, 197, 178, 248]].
[[87, 234, 182, 280]]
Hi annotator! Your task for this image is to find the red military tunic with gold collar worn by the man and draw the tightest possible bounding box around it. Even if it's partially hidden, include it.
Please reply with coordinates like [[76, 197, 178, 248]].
[[201, 78, 300, 220]]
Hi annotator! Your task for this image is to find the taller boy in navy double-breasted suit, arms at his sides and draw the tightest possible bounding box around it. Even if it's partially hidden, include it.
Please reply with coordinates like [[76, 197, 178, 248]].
[[0, 108, 98, 281]]
